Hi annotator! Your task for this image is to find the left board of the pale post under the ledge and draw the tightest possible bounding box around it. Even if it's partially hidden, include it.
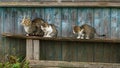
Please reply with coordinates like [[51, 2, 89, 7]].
[[26, 39, 34, 60]]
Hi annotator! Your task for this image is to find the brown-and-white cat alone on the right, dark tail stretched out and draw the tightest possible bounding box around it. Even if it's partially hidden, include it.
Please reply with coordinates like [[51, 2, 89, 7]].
[[73, 24, 105, 39]]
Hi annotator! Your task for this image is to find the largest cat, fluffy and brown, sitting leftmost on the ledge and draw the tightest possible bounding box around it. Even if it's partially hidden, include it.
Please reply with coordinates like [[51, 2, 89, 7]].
[[21, 17, 45, 37]]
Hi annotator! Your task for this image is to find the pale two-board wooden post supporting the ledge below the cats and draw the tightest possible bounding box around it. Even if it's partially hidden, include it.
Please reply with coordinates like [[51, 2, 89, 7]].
[[26, 39, 40, 60]]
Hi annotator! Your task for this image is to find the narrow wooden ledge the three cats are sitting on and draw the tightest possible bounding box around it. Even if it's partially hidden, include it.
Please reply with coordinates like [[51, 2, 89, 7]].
[[2, 33, 120, 43]]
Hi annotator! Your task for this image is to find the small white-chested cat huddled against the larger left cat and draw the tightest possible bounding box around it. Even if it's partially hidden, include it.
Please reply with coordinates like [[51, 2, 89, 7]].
[[41, 23, 58, 37]]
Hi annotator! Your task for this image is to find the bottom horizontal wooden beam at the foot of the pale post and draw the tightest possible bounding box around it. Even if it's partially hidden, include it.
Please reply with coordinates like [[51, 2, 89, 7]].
[[30, 60, 120, 68]]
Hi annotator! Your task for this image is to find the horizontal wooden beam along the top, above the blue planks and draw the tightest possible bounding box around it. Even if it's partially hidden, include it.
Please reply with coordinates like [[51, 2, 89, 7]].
[[0, 2, 120, 7]]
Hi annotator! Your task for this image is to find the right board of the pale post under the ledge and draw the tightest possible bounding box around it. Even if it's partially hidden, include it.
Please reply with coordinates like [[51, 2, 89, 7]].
[[33, 40, 40, 60]]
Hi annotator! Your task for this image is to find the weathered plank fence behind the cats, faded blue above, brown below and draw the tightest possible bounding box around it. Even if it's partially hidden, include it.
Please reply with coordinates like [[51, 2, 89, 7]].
[[0, 1, 120, 66]]
